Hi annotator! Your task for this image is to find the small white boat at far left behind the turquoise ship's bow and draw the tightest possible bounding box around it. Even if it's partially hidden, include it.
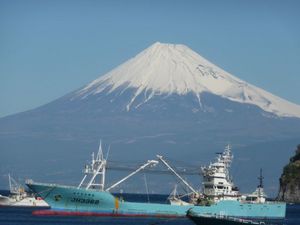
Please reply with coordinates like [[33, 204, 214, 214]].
[[0, 174, 49, 208]]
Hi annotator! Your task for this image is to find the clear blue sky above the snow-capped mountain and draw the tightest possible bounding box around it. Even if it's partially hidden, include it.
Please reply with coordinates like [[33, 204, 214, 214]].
[[0, 0, 300, 117]]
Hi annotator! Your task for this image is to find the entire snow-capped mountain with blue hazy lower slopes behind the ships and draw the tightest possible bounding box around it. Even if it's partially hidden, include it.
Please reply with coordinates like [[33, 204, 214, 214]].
[[0, 42, 300, 193]]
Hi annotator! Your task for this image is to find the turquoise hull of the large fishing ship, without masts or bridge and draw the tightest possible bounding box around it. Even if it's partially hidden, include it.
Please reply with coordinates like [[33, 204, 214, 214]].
[[27, 183, 286, 219]]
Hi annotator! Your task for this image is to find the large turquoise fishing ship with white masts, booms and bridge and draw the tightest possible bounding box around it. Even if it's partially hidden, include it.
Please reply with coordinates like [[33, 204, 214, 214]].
[[26, 144, 286, 219]]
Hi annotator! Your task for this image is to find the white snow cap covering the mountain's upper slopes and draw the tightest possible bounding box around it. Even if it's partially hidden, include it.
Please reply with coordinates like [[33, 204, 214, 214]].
[[76, 42, 300, 117]]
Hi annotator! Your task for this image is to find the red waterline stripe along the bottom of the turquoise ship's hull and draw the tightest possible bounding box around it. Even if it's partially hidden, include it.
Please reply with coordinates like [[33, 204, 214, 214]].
[[32, 210, 185, 218]]
